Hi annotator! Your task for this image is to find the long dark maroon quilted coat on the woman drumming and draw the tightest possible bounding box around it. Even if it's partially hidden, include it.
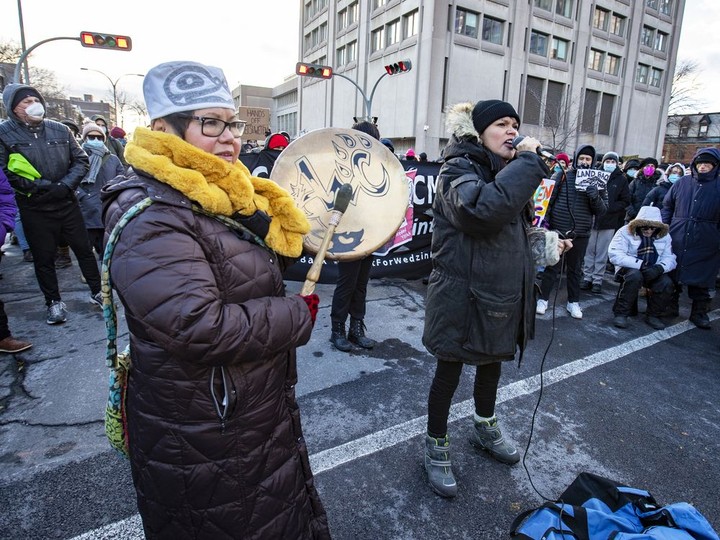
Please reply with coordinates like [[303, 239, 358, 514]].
[[103, 175, 330, 540]]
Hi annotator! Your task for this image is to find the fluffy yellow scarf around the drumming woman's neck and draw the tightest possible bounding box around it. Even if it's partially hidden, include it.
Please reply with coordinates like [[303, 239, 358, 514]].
[[125, 128, 310, 257]]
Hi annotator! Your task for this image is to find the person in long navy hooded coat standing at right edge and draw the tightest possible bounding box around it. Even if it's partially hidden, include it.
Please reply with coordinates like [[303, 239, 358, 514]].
[[662, 148, 720, 330]]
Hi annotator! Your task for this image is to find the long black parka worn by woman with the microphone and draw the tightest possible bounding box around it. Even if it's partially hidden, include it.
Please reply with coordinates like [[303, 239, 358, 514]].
[[423, 135, 549, 365]]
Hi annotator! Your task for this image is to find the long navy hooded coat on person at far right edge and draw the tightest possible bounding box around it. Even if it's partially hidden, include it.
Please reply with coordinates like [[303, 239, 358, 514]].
[[662, 148, 720, 288]]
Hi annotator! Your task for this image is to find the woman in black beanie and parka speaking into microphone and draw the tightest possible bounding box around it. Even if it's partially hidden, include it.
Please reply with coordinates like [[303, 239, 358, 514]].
[[423, 99, 571, 497]]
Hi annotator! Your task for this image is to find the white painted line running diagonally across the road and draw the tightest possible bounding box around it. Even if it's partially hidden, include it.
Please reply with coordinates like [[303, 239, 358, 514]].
[[71, 311, 720, 540]]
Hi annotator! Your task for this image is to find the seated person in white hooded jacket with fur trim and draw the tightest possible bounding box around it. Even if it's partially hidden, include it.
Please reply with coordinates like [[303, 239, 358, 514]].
[[608, 206, 676, 330]]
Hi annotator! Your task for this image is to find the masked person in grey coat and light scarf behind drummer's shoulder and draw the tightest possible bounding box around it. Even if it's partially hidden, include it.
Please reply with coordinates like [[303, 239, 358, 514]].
[[75, 123, 124, 258]]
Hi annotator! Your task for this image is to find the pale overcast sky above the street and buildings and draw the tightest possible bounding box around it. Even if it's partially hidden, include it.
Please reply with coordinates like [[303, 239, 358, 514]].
[[0, 0, 720, 117]]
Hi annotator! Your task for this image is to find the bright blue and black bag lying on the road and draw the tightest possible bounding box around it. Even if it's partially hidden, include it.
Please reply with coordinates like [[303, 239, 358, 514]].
[[510, 472, 719, 540]]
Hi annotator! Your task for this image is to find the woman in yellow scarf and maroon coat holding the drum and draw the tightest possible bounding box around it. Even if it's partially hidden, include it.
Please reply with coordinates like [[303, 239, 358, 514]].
[[102, 61, 330, 540]]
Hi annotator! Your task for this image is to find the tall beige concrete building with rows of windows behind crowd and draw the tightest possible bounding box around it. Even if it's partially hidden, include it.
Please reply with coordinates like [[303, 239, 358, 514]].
[[297, 0, 685, 158]]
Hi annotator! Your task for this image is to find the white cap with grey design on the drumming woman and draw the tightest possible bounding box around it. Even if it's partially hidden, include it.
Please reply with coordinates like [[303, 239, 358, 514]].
[[143, 61, 235, 120]]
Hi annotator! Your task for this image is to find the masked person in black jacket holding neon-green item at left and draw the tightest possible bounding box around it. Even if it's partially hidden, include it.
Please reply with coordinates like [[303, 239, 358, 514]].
[[0, 83, 102, 324]]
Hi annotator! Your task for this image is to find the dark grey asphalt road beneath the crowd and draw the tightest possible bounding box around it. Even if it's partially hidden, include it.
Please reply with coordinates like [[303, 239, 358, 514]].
[[0, 246, 720, 540]]
